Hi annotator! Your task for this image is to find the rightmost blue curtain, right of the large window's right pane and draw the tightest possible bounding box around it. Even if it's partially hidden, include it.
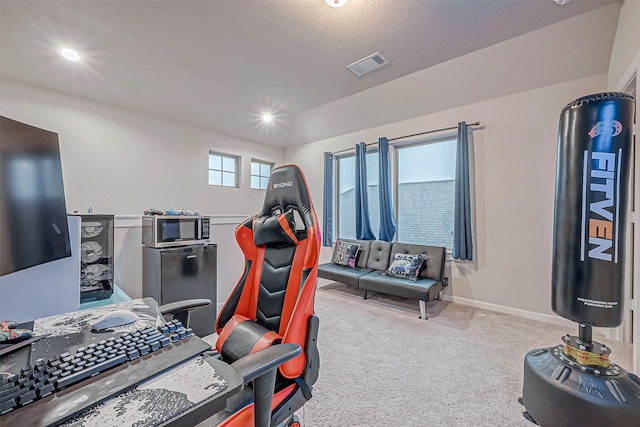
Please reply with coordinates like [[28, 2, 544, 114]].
[[452, 122, 473, 260]]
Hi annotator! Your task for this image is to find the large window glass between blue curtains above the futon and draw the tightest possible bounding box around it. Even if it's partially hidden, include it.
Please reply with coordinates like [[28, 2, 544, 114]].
[[335, 136, 457, 250]]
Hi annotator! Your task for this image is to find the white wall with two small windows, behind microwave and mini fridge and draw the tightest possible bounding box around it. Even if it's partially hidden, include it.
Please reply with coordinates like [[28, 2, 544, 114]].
[[0, 79, 283, 308]]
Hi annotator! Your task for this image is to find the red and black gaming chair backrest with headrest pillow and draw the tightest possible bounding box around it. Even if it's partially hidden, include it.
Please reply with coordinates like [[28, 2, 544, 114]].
[[216, 165, 321, 378]]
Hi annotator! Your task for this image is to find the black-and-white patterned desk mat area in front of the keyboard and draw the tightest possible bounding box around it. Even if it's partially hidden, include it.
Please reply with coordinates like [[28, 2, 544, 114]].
[[63, 357, 229, 427]]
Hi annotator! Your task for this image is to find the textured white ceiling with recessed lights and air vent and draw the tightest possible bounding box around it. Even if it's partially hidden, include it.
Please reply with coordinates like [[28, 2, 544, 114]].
[[0, 0, 615, 147]]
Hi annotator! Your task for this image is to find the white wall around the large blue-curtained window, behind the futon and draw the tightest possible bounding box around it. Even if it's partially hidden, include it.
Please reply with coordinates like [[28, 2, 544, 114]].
[[285, 74, 606, 322]]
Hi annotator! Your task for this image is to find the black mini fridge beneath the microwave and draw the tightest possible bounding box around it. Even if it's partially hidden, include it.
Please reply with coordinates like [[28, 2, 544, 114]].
[[142, 244, 217, 337]]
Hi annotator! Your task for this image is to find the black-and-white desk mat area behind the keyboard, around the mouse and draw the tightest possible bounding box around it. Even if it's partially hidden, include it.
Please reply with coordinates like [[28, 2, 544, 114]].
[[33, 299, 162, 336]]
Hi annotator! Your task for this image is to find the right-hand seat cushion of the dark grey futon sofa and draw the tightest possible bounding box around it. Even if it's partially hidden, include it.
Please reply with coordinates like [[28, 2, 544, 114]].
[[358, 271, 442, 301]]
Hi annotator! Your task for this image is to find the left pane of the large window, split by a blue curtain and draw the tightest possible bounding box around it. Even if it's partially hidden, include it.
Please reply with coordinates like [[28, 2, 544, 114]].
[[337, 151, 380, 239]]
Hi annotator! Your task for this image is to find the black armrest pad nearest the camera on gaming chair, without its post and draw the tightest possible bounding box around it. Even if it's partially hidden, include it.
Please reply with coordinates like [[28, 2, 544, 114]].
[[231, 344, 302, 383]]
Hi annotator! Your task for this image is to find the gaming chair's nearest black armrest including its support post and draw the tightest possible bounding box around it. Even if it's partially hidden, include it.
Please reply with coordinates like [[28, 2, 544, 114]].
[[231, 344, 302, 427]]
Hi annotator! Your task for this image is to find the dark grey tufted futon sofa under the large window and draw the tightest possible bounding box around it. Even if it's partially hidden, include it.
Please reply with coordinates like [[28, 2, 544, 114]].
[[318, 239, 448, 320]]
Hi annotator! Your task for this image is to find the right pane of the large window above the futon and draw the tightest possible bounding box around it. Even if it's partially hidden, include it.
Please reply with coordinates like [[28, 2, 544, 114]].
[[398, 141, 456, 249]]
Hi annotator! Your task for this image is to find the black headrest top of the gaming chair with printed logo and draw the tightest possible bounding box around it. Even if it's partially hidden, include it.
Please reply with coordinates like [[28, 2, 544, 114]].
[[260, 165, 314, 229]]
